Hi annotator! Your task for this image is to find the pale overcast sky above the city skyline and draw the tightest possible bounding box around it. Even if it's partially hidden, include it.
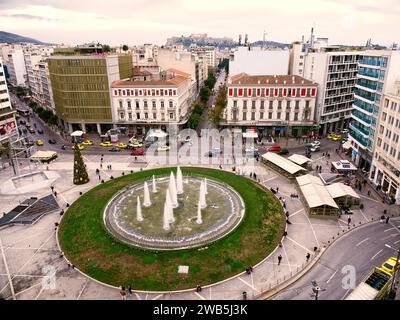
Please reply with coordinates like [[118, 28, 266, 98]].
[[0, 0, 400, 45]]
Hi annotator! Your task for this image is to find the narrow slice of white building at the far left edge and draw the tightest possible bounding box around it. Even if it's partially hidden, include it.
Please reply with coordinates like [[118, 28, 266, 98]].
[[0, 58, 17, 142]]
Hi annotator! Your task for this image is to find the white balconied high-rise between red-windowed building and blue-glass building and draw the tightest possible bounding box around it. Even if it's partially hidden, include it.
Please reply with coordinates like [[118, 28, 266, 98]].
[[302, 49, 360, 135]]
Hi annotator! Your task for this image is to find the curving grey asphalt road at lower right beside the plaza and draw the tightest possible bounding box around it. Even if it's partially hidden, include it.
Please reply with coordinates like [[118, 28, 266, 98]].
[[273, 217, 400, 300]]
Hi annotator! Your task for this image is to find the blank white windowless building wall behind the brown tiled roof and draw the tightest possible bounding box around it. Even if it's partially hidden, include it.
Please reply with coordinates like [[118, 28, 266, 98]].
[[229, 47, 290, 76]]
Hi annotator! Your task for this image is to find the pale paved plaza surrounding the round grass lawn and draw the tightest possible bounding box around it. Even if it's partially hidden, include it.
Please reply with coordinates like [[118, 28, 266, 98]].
[[0, 145, 398, 300]]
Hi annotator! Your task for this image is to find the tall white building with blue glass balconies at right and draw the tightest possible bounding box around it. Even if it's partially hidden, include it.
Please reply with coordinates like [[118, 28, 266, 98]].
[[349, 50, 400, 171]]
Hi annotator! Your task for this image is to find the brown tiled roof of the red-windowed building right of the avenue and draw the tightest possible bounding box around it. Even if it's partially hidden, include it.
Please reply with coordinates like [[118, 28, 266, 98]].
[[228, 73, 316, 85]]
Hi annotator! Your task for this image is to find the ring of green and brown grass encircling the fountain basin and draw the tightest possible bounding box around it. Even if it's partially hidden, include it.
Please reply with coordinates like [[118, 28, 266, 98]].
[[58, 167, 285, 291]]
